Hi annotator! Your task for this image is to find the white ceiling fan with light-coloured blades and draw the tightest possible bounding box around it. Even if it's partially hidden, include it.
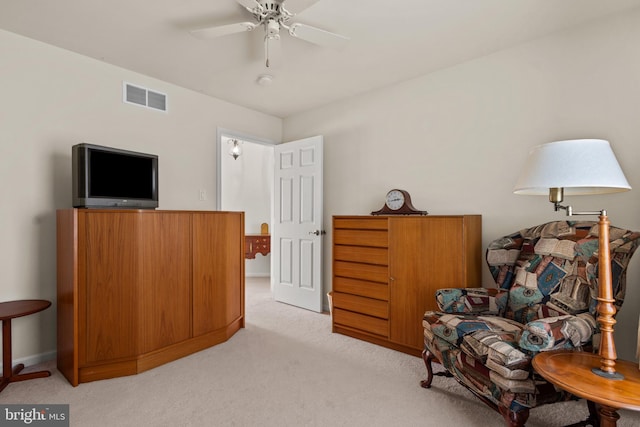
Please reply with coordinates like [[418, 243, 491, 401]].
[[190, 0, 349, 67]]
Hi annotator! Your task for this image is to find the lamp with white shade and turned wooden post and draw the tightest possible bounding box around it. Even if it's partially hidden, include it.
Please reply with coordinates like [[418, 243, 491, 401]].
[[514, 139, 631, 379]]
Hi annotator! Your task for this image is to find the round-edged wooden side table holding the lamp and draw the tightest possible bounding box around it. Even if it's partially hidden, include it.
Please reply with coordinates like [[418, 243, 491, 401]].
[[532, 350, 640, 427]]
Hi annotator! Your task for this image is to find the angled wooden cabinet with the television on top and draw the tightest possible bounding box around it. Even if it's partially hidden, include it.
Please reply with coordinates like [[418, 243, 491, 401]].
[[57, 209, 244, 385]]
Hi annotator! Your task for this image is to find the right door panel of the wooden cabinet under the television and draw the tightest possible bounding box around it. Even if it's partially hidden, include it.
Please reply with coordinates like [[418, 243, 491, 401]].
[[192, 212, 244, 336]]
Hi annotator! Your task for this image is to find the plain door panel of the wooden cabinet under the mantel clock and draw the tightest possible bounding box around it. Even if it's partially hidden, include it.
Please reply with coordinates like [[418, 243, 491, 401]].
[[389, 217, 464, 348]]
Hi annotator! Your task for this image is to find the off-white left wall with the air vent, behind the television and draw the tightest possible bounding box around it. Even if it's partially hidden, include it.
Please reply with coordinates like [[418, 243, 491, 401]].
[[0, 31, 282, 360]]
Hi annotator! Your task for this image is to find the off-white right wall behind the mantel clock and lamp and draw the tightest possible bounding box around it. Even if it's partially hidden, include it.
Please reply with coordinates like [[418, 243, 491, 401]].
[[283, 9, 640, 359]]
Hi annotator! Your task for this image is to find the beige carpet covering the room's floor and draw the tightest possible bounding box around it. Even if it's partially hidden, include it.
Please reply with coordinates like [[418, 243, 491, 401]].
[[0, 278, 640, 427]]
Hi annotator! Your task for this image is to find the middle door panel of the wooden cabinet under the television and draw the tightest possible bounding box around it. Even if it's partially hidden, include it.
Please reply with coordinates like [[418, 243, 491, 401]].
[[138, 212, 191, 353]]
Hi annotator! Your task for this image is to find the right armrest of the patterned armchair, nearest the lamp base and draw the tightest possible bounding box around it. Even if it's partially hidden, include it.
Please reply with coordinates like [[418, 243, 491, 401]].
[[520, 313, 596, 353]]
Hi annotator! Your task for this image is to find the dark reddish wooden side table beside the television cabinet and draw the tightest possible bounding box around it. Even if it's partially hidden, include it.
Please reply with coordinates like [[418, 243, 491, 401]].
[[0, 299, 51, 391]]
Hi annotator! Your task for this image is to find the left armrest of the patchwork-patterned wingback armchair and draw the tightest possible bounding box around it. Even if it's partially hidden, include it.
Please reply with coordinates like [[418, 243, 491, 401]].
[[436, 288, 509, 316]]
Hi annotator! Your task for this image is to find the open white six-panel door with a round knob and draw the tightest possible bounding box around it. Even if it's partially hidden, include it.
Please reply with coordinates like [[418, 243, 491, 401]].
[[271, 136, 324, 312]]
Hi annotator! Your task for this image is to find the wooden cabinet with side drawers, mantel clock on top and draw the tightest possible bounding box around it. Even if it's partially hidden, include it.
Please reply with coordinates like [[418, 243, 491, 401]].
[[332, 215, 482, 355]]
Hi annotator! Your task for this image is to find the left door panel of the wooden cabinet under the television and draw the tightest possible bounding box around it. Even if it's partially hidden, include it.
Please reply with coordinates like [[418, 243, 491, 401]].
[[78, 212, 138, 365]]
